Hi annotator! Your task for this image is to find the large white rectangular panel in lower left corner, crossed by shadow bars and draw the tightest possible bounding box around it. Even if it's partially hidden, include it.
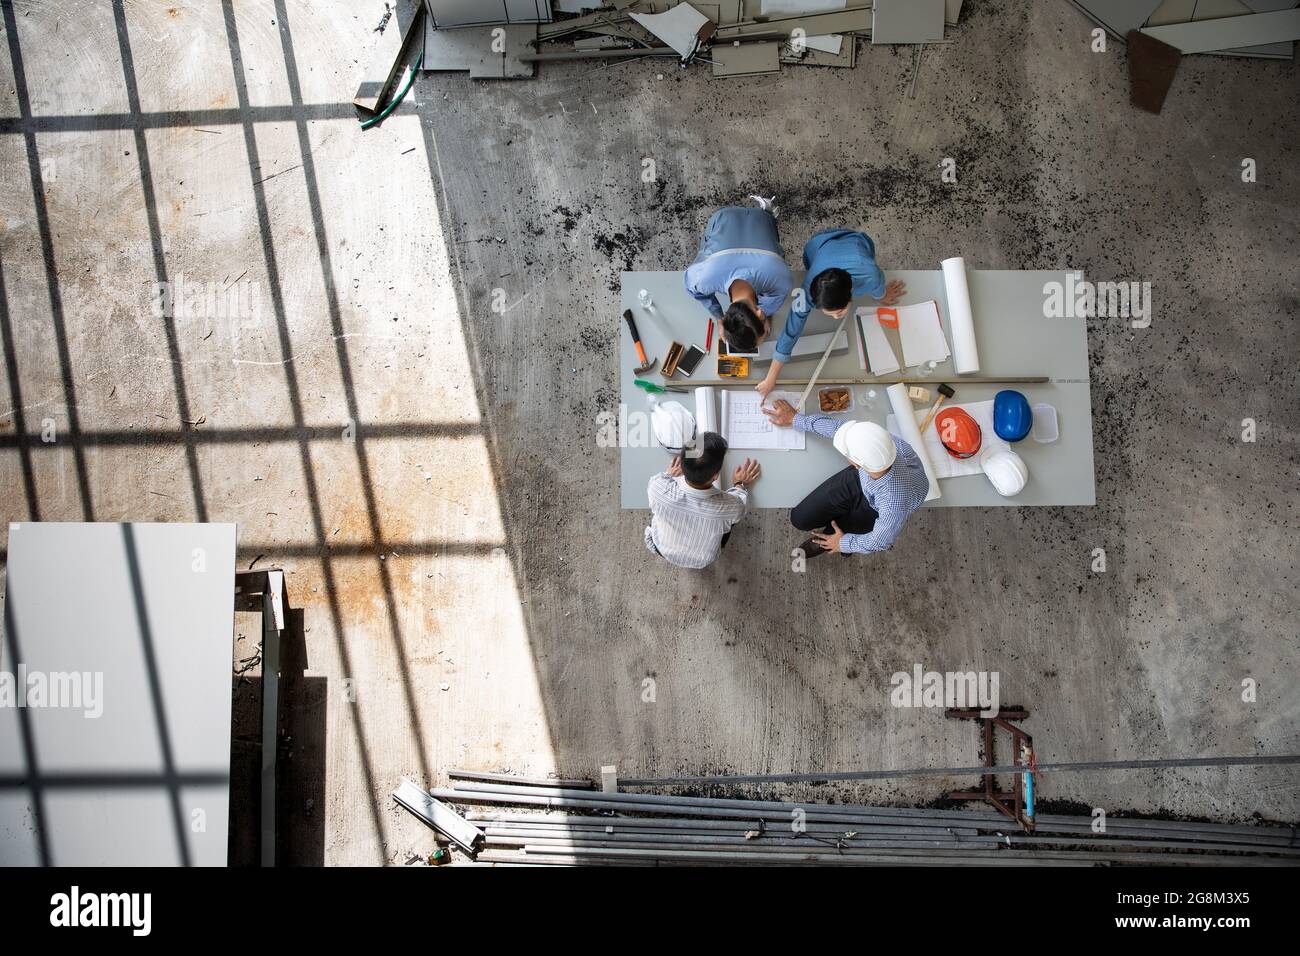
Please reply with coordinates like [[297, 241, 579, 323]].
[[0, 523, 235, 866]]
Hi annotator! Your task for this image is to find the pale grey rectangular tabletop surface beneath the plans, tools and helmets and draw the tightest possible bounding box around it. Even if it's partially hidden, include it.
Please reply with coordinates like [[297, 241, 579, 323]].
[[619, 269, 1096, 509]]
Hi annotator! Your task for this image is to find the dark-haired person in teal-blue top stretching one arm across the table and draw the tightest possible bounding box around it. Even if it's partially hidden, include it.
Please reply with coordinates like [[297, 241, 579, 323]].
[[754, 229, 907, 399]]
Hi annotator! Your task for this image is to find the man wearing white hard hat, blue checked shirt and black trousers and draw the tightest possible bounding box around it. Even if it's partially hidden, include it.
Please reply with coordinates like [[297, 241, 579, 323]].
[[763, 401, 930, 558]]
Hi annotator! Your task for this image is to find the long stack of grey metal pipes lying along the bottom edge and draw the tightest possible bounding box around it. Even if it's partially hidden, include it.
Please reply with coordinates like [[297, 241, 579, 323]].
[[430, 771, 1300, 866]]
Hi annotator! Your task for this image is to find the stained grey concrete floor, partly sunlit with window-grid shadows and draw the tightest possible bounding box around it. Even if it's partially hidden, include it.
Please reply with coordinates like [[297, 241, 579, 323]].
[[0, 0, 1300, 864]]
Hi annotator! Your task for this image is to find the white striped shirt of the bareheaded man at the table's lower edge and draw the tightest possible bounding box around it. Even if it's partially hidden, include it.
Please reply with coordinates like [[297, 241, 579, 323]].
[[646, 472, 749, 568]]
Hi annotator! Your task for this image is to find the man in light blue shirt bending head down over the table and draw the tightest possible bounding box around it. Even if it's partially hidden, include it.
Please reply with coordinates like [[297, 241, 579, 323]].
[[685, 200, 794, 352]]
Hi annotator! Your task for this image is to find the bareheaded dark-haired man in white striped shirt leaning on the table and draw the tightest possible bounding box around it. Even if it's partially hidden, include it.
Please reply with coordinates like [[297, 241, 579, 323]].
[[646, 432, 759, 568]]
